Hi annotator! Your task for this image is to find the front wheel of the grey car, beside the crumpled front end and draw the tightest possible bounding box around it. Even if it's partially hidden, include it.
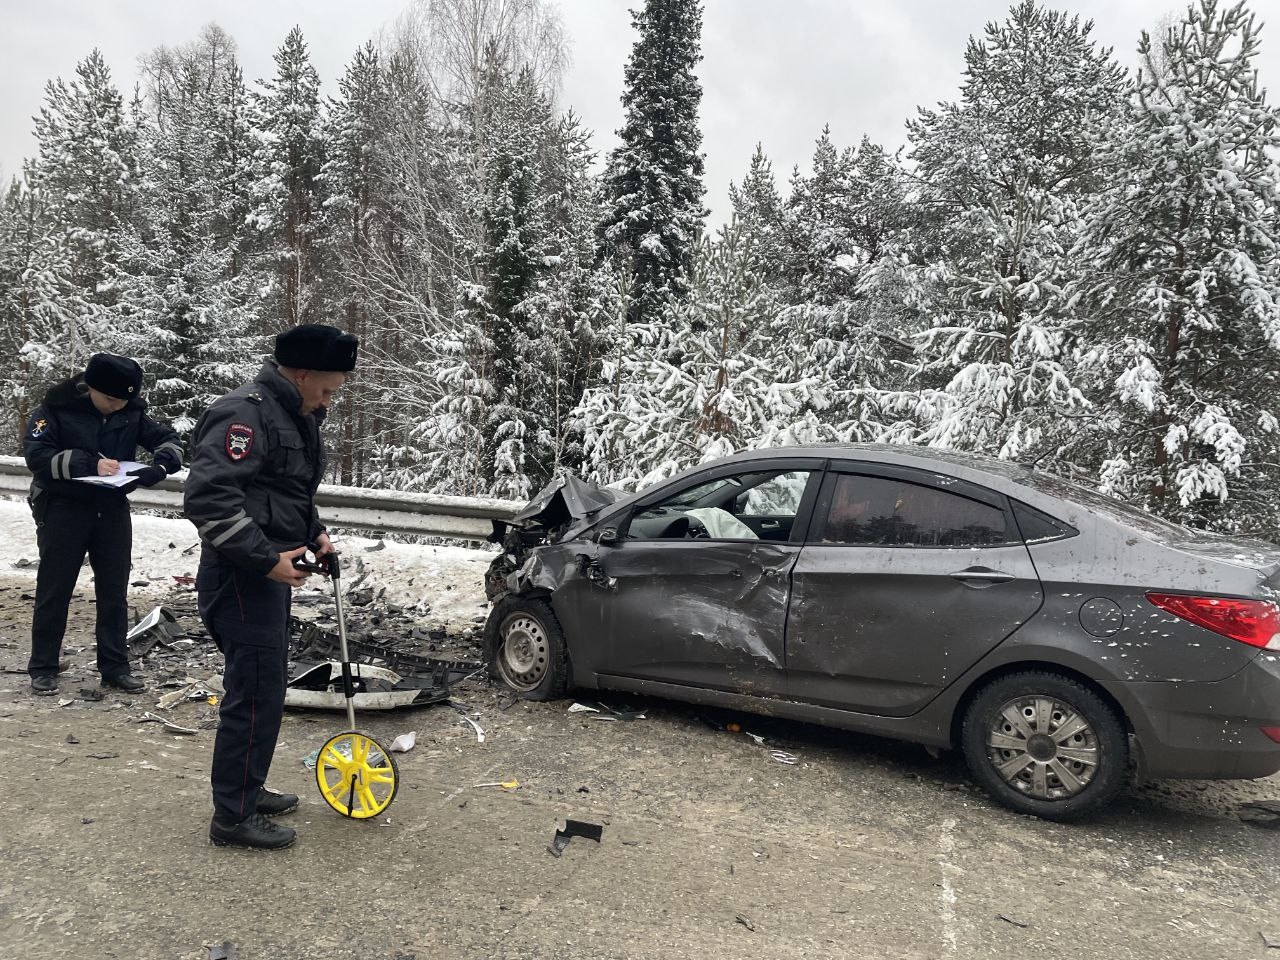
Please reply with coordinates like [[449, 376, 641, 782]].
[[485, 595, 568, 700]]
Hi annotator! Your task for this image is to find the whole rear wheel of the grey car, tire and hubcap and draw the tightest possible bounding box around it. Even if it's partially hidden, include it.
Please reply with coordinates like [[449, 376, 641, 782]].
[[960, 671, 1129, 820]]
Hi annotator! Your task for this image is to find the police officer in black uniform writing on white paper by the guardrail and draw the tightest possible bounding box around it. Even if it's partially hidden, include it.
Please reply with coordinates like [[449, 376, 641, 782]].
[[22, 353, 182, 694]]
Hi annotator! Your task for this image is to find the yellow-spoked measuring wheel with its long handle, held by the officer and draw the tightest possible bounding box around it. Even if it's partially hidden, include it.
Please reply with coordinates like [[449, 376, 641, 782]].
[[293, 553, 399, 820]]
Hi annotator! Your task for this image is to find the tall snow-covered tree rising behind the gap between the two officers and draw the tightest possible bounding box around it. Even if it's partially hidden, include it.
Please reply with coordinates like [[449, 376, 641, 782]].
[[128, 24, 262, 433]]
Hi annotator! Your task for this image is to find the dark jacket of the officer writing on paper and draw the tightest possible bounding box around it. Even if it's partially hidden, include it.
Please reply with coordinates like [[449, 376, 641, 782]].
[[22, 378, 182, 506]]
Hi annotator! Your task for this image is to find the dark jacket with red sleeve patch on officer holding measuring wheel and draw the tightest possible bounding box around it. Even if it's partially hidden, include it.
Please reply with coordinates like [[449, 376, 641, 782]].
[[183, 361, 325, 576]]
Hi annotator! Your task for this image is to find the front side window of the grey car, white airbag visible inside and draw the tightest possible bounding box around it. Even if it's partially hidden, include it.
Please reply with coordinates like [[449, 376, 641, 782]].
[[627, 470, 812, 540]]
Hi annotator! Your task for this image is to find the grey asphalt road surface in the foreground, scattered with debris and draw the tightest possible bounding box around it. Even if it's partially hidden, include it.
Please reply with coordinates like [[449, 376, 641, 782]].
[[0, 580, 1280, 960]]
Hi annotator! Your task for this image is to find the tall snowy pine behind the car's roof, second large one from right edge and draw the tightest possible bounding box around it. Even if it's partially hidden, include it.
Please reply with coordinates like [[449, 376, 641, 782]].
[[897, 0, 1123, 458]]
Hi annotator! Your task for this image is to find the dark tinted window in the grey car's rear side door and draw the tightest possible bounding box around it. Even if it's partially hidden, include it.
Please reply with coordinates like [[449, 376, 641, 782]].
[[817, 474, 1019, 547]]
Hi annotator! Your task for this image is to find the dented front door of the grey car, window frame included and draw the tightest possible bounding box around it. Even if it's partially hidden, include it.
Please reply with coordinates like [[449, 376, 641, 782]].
[[577, 460, 822, 696]]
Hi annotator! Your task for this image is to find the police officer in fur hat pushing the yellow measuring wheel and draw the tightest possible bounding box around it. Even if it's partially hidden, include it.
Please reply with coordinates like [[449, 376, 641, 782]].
[[184, 324, 358, 850]]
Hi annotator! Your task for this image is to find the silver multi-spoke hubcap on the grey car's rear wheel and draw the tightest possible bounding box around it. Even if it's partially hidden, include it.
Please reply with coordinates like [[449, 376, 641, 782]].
[[987, 696, 1102, 800]]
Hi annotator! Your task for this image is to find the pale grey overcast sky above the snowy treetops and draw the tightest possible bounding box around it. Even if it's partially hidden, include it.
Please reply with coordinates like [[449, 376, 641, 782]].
[[0, 0, 1280, 223]]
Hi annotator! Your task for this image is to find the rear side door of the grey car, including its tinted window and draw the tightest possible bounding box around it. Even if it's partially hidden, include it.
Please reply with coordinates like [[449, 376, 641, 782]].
[[786, 462, 1043, 717]]
